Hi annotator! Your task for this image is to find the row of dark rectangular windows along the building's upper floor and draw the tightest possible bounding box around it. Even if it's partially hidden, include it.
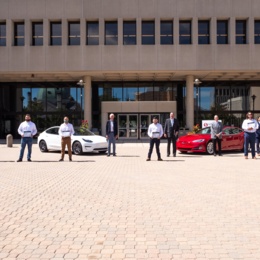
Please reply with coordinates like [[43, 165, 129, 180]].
[[0, 20, 260, 46]]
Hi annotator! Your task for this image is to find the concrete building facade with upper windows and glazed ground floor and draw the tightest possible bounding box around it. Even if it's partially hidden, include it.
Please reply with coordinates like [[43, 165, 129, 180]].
[[0, 0, 260, 139]]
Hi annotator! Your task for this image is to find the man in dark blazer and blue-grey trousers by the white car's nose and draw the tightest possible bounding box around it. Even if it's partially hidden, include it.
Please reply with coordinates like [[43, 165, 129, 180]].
[[106, 114, 117, 157]]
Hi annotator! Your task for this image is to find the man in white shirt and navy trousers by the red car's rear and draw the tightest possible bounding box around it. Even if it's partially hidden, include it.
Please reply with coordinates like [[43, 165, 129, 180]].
[[242, 112, 258, 159]]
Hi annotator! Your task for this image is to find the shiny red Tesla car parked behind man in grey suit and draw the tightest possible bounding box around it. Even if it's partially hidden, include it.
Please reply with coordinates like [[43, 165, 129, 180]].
[[176, 126, 244, 154]]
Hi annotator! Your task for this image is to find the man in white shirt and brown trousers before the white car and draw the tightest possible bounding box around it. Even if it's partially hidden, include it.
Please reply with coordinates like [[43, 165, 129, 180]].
[[59, 116, 74, 162]]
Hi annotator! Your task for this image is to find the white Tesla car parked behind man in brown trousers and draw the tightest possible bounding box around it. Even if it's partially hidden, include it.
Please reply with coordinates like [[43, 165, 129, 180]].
[[37, 126, 107, 155]]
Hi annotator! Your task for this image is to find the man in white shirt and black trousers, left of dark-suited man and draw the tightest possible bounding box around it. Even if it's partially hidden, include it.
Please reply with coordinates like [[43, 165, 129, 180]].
[[146, 117, 163, 161]]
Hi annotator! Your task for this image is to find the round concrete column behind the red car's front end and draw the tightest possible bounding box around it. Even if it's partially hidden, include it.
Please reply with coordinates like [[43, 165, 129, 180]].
[[186, 75, 194, 130]]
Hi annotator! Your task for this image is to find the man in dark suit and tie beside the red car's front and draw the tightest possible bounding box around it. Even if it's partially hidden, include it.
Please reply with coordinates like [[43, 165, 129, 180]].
[[164, 112, 179, 157]]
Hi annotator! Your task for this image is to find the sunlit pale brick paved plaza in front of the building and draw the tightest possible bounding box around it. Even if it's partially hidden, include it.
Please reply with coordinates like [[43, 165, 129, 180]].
[[0, 143, 260, 260]]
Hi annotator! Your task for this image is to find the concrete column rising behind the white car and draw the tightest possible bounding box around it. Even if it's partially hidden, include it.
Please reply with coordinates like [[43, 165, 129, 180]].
[[83, 76, 92, 129]]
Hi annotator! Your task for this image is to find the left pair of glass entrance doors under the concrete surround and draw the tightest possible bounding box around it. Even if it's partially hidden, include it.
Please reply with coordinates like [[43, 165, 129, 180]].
[[118, 114, 138, 139]]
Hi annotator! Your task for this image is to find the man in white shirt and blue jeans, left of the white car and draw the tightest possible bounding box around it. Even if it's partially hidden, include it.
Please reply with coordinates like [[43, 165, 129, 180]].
[[17, 114, 37, 162]]
